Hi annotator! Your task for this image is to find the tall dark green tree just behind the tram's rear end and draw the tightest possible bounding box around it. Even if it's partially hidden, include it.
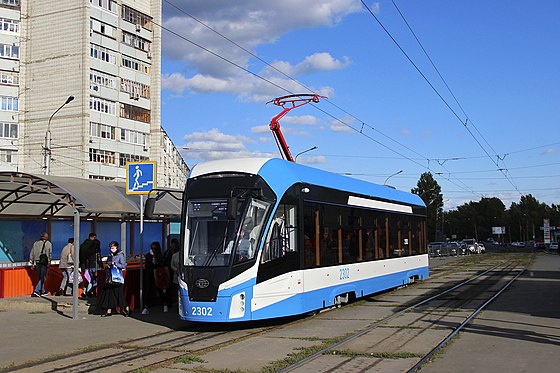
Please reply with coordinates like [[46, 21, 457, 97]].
[[410, 172, 443, 241]]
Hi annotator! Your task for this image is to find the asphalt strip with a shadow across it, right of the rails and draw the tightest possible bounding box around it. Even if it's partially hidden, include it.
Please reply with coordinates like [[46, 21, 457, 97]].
[[422, 253, 560, 373]]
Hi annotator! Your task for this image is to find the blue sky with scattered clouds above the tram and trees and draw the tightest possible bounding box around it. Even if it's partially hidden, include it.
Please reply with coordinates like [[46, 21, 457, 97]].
[[155, 0, 560, 210]]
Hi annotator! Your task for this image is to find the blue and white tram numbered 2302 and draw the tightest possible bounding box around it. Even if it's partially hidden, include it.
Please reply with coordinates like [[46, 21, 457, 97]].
[[179, 158, 428, 322]]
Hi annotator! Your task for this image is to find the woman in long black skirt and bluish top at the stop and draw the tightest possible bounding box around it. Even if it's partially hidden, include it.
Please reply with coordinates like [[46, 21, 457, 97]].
[[97, 241, 130, 317]]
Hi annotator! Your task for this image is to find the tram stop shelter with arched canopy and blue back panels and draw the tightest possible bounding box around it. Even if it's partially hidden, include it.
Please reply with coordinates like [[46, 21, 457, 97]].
[[0, 171, 182, 320]]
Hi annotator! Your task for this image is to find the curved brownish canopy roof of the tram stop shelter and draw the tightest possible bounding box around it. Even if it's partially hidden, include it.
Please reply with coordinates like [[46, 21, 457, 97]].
[[0, 171, 182, 218]]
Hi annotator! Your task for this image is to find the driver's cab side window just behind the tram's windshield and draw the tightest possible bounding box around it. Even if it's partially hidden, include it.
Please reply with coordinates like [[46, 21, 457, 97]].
[[262, 204, 297, 263]]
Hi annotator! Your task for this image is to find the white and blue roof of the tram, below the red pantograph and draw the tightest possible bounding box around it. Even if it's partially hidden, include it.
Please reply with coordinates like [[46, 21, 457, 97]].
[[189, 158, 425, 206]]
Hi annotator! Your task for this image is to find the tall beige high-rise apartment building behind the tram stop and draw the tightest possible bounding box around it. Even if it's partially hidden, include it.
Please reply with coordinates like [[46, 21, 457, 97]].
[[0, 0, 188, 188]]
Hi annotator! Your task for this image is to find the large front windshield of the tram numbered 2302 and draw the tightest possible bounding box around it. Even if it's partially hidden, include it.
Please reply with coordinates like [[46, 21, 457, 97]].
[[184, 198, 270, 267]]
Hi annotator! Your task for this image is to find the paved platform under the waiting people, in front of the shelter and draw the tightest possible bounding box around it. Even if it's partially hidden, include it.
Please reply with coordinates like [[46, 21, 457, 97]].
[[0, 296, 187, 370]]
